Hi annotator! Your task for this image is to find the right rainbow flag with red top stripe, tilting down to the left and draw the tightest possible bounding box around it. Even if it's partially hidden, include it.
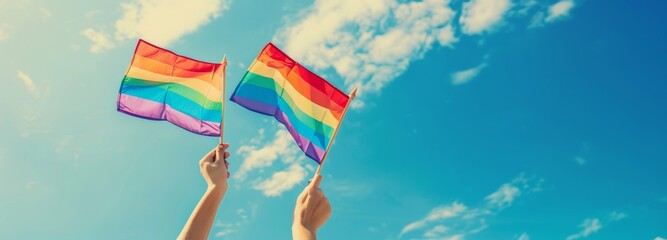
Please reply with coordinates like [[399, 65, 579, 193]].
[[231, 43, 350, 163]]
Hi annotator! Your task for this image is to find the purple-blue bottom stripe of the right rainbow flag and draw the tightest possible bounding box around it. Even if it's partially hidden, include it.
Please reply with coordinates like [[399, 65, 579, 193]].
[[232, 95, 324, 163]]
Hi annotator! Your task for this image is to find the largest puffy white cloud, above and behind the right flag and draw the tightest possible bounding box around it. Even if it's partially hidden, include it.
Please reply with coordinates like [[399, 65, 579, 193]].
[[275, 0, 458, 107]]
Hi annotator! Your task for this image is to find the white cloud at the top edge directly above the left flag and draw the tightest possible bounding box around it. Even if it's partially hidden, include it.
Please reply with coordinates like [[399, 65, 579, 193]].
[[115, 0, 230, 46]]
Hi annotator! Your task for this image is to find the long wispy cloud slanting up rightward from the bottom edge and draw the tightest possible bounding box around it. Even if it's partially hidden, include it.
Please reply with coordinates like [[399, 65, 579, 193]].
[[398, 174, 542, 239]]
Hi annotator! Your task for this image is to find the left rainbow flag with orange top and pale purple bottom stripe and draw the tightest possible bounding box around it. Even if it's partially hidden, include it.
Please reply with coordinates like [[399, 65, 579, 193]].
[[118, 39, 224, 136]]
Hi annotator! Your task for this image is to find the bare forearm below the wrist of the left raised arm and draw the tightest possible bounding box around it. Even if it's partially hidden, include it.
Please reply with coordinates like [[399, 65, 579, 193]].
[[178, 187, 225, 240]]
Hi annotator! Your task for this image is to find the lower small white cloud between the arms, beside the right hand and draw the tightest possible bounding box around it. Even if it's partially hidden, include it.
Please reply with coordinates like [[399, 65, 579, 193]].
[[253, 163, 308, 197]]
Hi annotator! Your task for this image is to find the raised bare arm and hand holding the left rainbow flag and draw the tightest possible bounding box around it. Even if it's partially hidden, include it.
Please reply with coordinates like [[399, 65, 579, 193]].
[[178, 144, 229, 240]]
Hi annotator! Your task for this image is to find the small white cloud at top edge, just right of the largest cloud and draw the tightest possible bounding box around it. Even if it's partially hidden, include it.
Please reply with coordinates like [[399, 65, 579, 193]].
[[459, 0, 512, 34]]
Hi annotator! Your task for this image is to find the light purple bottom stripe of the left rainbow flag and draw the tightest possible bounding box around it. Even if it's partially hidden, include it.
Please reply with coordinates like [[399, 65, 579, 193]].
[[118, 94, 220, 136]]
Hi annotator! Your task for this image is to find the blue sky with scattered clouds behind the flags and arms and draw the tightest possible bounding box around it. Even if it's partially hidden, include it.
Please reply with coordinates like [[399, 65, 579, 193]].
[[0, 0, 667, 240]]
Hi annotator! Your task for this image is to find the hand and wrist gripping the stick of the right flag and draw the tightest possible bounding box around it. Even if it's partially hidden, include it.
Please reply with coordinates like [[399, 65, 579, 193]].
[[292, 174, 331, 240]]
